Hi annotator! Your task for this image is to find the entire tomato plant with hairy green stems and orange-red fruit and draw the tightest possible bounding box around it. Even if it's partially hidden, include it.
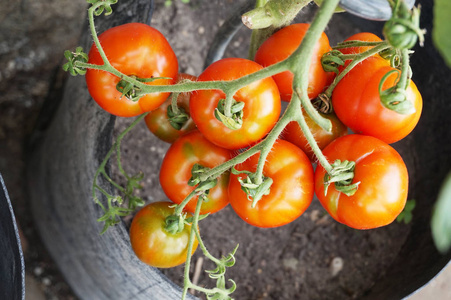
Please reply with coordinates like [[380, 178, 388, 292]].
[[63, 0, 423, 299]]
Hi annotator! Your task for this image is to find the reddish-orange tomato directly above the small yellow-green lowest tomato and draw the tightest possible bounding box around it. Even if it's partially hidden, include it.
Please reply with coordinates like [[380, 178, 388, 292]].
[[160, 130, 233, 214]]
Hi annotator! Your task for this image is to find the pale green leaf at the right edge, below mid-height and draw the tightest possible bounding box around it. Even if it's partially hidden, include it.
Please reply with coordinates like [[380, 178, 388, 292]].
[[431, 173, 451, 253]]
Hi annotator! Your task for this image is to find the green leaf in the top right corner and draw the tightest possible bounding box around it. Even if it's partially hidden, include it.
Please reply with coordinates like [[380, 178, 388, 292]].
[[432, 0, 451, 68]]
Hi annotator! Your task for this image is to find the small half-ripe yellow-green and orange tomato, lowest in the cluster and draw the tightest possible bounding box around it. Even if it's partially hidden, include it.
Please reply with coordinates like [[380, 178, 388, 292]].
[[130, 202, 198, 268]]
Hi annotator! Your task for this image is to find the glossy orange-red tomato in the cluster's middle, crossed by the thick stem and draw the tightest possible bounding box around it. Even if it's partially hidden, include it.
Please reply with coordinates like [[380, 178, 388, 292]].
[[190, 58, 281, 149]]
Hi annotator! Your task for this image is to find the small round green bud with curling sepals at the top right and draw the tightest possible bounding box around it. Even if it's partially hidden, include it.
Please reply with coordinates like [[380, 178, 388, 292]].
[[383, 0, 425, 49]]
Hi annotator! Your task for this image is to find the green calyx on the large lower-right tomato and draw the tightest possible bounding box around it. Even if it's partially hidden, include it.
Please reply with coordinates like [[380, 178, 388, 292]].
[[324, 159, 360, 196]]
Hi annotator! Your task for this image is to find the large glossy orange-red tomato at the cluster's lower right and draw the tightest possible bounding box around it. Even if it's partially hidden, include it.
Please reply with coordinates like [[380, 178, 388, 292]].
[[315, 134, 408, 229]]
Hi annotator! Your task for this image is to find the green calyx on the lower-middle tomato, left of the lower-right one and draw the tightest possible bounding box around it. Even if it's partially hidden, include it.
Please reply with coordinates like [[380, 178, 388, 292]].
[[232, 167, 273, 208]]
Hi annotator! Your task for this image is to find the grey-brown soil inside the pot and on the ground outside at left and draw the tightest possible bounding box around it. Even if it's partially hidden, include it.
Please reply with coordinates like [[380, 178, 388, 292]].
[[0, 0, 409, 300]]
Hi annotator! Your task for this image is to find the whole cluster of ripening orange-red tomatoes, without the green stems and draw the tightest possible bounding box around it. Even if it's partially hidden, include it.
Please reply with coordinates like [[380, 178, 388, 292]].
[[86, 23, 422, 267]]
